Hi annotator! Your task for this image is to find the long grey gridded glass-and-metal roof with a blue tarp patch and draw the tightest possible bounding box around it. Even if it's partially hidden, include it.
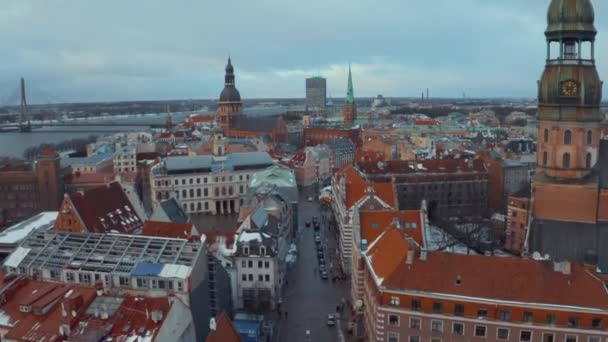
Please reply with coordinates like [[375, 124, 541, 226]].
[[3, 230, 201, 279]]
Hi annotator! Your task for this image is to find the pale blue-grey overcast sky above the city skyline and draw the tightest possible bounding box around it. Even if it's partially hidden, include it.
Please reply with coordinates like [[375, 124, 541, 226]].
[[0, 0, 608, 102]]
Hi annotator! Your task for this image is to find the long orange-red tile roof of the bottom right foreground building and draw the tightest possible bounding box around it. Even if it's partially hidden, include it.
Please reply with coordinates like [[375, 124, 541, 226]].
[[376, 240, 608, 310]]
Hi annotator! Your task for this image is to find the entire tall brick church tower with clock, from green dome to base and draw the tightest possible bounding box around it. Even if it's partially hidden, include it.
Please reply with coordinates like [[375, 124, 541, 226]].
[[528, 0, 608, 271]]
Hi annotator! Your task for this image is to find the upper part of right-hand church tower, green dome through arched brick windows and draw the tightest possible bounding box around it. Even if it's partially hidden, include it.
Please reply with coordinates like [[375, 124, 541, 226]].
[[537, 0, 603, 181]]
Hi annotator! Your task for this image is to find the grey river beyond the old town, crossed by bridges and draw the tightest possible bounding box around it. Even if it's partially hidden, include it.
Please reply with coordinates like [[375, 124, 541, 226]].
[[0, 106, 301, 158]]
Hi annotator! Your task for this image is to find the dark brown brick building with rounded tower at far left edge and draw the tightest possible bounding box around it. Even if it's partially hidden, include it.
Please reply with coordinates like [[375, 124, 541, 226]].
[[0, 148, 63, 223]]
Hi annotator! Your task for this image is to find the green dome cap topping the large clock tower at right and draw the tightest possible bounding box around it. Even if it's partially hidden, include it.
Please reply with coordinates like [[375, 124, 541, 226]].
[[545, 0, 597, 40]]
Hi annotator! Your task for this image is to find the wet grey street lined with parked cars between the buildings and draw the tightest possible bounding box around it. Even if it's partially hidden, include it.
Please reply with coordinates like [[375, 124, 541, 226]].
[[275, 191, 349, 342]]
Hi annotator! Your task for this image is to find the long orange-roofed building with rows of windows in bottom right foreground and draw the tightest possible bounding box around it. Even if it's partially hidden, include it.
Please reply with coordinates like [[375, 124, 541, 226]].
[[362, 228, 608, 342]]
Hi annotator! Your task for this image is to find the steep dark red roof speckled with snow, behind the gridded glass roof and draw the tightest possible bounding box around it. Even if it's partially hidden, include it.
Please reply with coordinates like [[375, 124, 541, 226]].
[[69, 182, 143, 233]]
